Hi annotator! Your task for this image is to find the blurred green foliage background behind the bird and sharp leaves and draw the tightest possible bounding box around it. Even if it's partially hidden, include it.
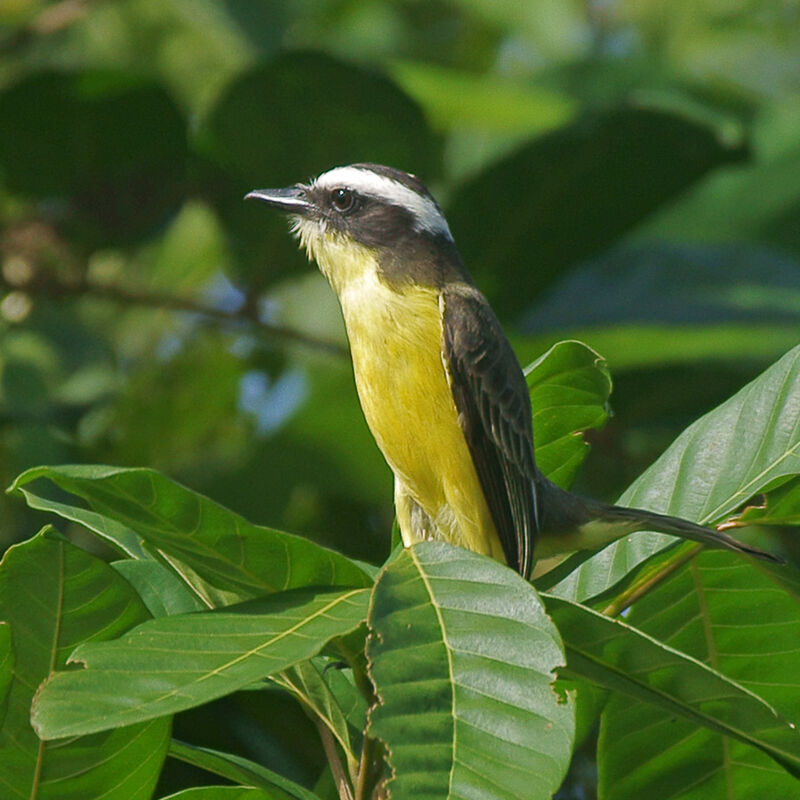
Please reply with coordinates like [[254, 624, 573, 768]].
[[0, 0, 800, 797]]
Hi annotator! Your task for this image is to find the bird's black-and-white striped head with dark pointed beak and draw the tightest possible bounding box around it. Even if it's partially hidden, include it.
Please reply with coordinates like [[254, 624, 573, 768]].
[[247, 164, 463, 291]]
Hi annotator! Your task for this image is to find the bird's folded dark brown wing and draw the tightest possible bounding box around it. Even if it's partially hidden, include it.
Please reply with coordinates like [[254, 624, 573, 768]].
[[442, 283, 538, 578]]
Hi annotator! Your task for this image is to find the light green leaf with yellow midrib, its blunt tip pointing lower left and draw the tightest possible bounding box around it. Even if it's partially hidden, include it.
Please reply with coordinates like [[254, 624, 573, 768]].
[[31, 589, 369, 739]]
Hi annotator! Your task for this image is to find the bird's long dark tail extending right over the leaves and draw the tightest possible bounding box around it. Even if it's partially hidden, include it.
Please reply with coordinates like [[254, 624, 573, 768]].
[[537, 478, 785, 564]]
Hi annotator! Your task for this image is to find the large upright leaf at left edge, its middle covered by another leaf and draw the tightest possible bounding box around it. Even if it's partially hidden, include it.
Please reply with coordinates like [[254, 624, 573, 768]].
[[0, 529, 170, 800]]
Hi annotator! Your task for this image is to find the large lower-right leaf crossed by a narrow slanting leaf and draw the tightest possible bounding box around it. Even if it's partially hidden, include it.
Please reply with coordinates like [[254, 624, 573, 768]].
[[598, 551, 800, 800]]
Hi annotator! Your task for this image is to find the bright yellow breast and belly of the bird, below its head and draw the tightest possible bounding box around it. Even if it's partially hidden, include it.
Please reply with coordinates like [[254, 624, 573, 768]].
[[339, 270, 504, 560]]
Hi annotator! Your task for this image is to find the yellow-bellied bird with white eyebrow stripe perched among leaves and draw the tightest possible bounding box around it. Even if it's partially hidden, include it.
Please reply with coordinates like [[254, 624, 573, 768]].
[[245, 163, 781, 578]]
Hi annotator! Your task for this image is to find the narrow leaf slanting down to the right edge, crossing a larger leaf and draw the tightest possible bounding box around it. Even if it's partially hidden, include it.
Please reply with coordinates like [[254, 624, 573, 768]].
[[545, 596, 800, 780]]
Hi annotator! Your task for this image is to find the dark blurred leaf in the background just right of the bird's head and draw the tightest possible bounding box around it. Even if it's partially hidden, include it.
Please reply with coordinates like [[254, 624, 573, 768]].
[[448, 108, 742, 317]]
